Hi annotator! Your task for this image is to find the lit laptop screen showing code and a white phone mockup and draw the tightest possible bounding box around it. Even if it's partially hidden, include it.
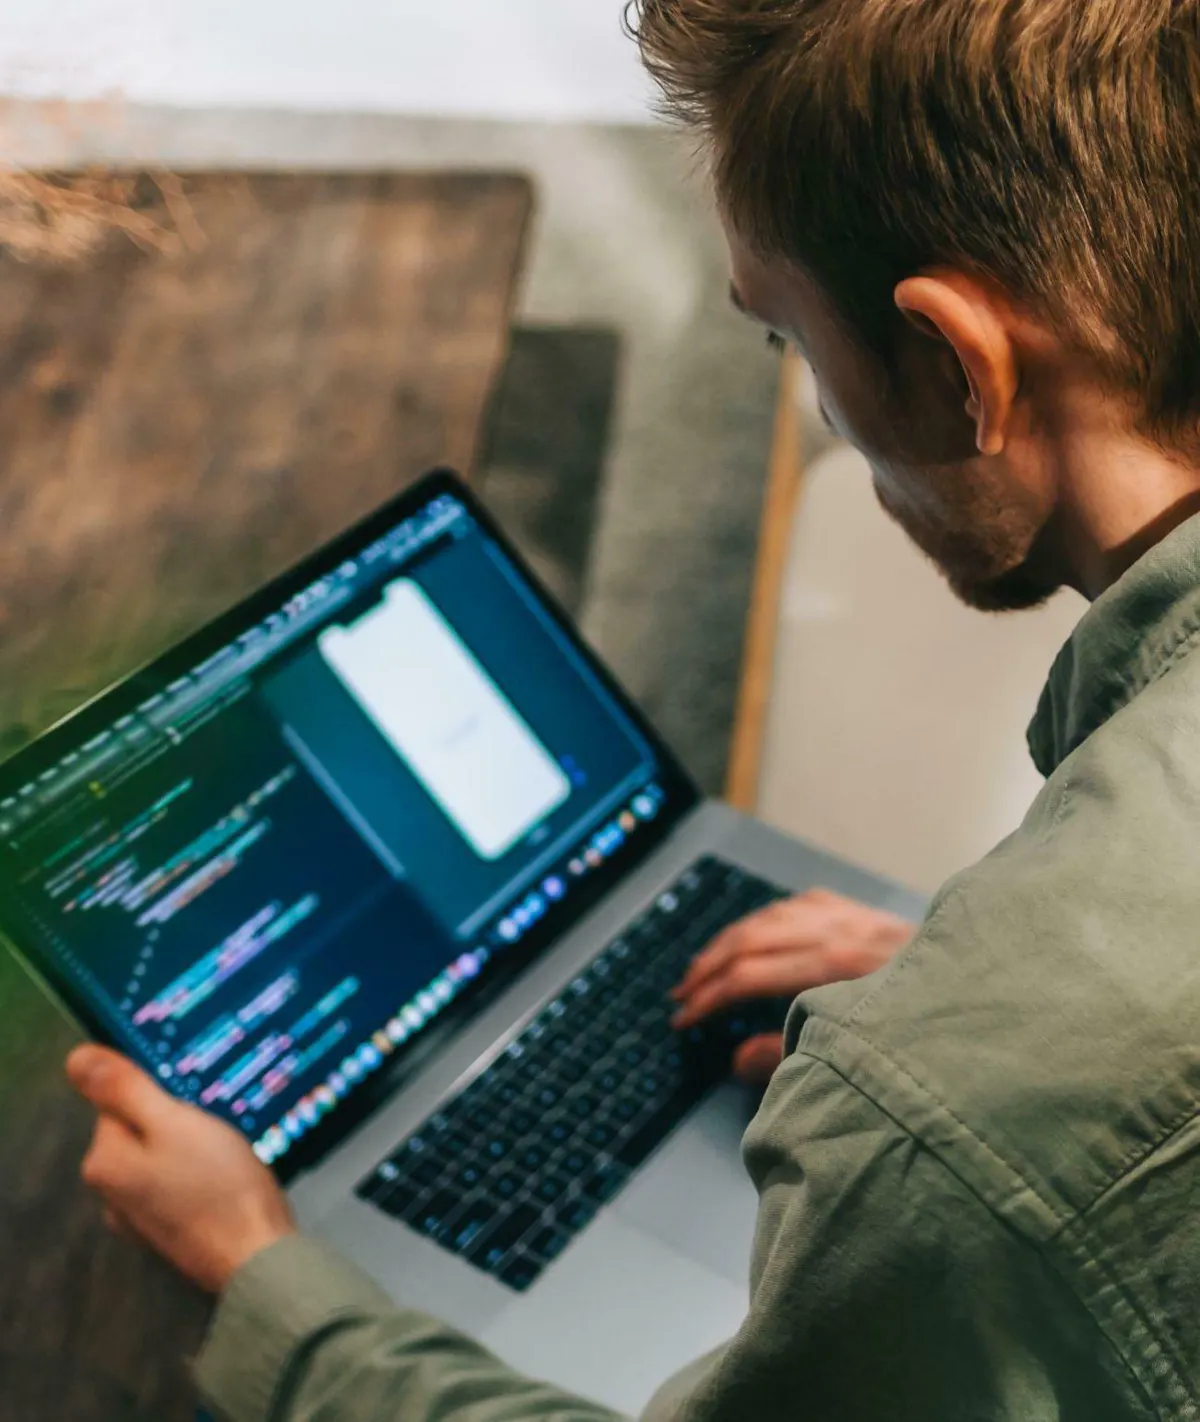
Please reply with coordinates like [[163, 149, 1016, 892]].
[[0, 476, 694, 1163]]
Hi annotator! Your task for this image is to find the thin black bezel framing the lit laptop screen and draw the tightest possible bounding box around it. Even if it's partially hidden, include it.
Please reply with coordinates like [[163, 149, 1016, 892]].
[[0, 469, 702, 1182]]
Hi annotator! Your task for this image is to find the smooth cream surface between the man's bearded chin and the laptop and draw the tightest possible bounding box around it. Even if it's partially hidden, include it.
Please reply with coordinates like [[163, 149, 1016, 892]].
[[758, 383, 1085, 893]]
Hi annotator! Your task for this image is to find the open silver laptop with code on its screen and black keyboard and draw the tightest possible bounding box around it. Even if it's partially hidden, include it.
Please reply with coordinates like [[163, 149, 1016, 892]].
[[0, 472, 921, 1411]]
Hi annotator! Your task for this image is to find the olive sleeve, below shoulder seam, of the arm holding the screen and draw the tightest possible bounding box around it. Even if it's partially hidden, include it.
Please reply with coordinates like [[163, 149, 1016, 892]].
[[191, 1052, 1150, 1422]]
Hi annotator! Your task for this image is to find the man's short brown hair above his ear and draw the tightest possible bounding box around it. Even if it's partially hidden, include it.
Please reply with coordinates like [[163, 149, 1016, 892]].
[[628, 0, 1200, 445]]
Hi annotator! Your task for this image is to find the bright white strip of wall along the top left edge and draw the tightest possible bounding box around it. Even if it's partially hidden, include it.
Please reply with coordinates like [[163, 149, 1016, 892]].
[[0, 0, 650, 122]]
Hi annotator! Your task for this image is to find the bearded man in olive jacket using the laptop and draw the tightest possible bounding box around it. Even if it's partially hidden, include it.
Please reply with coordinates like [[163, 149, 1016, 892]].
[[70, 0, 1200, 1422]]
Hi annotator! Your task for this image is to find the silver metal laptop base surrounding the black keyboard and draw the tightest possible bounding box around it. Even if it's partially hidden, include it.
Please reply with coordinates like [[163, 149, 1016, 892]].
[[291, 802, 923, 1413]]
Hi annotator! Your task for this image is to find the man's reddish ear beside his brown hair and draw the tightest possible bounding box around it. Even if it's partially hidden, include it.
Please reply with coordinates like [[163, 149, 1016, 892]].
[[894, 272, 1018, 455]]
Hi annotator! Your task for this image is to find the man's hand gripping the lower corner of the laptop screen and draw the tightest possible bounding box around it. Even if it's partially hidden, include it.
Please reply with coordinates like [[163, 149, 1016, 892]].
[[67, 1047, 296, 1294]]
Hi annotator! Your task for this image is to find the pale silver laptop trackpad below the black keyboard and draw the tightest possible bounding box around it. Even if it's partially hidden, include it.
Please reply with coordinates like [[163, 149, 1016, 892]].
[[482, 1213, 749, 1415]]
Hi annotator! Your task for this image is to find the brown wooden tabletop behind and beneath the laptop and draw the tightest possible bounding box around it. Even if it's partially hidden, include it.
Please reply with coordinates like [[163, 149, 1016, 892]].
[[0, 173, 530, 1422]]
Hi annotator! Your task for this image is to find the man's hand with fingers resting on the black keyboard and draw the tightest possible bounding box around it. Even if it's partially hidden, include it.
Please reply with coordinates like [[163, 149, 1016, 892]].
[[673, 889, 916, 1082]]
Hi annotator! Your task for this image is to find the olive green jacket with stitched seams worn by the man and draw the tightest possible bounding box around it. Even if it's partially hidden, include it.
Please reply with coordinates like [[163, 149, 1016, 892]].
[[198, 518, 1200, 1422]]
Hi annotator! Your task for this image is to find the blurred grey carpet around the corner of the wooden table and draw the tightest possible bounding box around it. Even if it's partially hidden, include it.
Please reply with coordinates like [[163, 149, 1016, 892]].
[[4, 108, 778, 791]]
